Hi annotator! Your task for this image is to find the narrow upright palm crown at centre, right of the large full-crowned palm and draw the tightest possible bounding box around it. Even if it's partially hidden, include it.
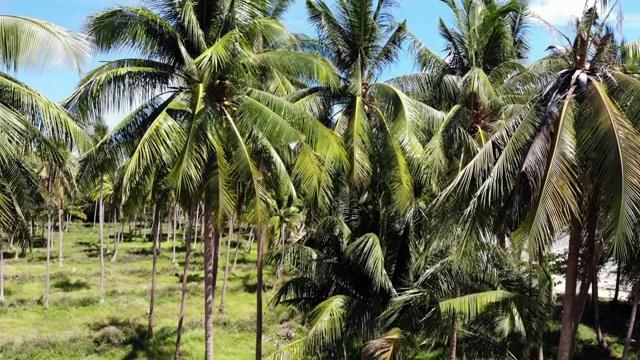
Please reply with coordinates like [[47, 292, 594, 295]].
[[290, 0, 444, 217]]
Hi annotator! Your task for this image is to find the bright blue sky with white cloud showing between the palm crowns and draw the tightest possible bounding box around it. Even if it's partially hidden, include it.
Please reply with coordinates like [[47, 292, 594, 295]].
[[0, 0, 640, 126]]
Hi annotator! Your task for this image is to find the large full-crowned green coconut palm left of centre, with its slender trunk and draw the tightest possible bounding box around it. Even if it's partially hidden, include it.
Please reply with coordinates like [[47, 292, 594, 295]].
[[67, 0, 341, 359]]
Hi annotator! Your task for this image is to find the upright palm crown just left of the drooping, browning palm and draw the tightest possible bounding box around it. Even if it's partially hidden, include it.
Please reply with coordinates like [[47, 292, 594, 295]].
[[391, 0, 530, 191]]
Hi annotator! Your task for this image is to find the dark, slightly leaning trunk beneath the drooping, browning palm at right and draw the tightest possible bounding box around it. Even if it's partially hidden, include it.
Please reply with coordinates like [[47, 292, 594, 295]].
[[558, 219, 582, 360]]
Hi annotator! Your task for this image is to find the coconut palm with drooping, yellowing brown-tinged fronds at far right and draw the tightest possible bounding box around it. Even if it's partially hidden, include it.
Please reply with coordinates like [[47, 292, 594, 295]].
[[440, 7, 640, 360]]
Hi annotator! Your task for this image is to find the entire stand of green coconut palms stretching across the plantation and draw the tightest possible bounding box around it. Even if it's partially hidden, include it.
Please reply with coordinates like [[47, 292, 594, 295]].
[[0, 0, 640, 360]]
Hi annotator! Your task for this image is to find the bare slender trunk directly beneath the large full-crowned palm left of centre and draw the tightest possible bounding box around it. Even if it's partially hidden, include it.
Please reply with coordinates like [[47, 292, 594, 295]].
[[202, 200, 220, 360]]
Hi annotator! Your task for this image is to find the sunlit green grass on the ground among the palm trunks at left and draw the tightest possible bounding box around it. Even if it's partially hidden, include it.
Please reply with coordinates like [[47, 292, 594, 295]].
[[0, 223, 305, 359]]
